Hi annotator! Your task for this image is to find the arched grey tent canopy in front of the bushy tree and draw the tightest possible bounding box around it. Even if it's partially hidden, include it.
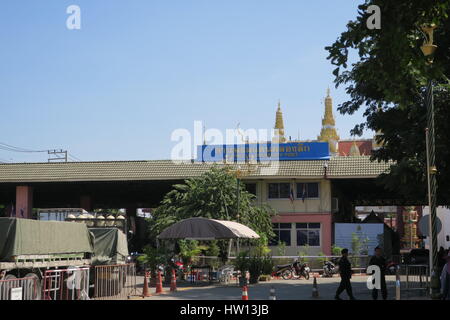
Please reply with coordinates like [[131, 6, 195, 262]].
[[158, 218, 259, 240]]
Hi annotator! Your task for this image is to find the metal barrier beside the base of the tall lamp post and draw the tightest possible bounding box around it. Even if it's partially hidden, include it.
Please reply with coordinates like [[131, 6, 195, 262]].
[[396, 265, 430, 300]]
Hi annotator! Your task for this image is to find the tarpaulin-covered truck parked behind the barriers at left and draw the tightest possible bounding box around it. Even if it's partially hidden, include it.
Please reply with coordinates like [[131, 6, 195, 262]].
[[0, 218, 128, 298]]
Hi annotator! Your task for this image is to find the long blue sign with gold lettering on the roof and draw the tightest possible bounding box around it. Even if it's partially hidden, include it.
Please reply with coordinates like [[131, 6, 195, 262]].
[[197, 142, 330, 162]]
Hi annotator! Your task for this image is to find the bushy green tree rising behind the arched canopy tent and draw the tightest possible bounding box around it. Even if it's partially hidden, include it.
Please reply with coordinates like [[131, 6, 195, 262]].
[[149, 167, 274, 255]]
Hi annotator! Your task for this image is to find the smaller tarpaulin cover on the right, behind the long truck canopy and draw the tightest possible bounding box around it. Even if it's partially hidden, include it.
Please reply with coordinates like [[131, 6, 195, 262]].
[[89, 228, 128, 264]]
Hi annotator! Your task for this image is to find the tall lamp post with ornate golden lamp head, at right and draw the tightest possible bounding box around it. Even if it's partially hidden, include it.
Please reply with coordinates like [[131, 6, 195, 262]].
[[420, 25, 440, 299]]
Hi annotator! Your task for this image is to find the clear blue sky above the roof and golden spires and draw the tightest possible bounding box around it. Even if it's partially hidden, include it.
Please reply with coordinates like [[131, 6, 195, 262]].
[[0, 0, 372, 162]]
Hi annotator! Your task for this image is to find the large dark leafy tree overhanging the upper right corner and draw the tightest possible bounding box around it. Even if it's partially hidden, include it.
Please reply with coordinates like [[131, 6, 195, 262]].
[[326, 0, 450, 204]]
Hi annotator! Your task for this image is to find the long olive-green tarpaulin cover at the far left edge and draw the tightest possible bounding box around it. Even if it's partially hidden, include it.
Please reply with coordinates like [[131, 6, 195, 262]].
[[0, 218, 94, 261]]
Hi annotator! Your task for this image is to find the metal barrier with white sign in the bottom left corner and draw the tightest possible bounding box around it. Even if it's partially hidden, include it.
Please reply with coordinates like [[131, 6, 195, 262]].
[[0, 277, 40, 300]]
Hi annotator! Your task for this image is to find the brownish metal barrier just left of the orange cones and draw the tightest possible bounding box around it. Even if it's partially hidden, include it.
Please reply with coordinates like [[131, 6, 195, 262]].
[[93, 264, 137, 300]]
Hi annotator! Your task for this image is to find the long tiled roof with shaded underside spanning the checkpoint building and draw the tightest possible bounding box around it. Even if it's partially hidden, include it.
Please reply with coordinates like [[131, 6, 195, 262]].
[[0, 156, 396, 218]]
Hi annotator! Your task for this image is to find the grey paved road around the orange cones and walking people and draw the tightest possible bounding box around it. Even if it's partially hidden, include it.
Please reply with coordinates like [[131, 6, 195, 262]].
[[132, 276, 410, 300]]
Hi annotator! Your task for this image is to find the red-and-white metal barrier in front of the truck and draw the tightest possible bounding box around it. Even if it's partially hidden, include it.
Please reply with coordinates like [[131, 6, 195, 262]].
[[42, 267, 90, 300]]
